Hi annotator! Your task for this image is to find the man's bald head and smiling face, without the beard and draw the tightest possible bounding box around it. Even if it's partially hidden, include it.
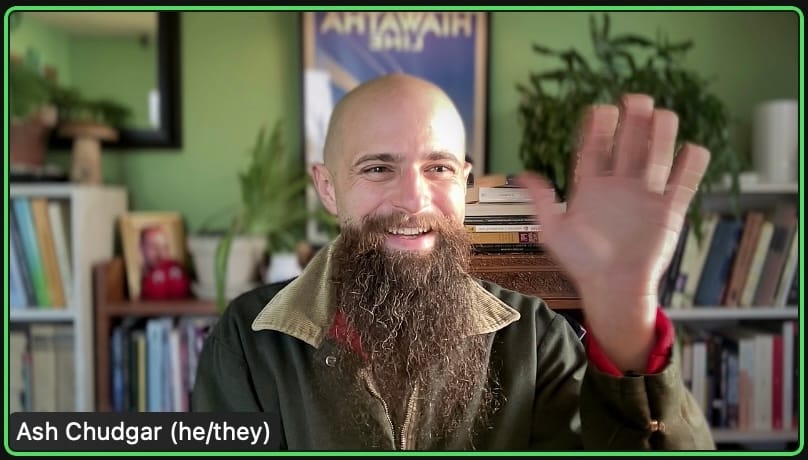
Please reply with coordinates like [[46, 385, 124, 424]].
[[311, 74, 471, 229]]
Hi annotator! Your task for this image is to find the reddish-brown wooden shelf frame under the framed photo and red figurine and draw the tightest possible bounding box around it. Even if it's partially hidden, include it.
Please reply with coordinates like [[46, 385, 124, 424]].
[[93, 258, 218, 412]]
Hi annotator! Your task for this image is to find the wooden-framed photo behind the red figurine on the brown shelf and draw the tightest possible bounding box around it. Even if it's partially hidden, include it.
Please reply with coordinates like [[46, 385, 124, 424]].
[[120, 212, 186, 300]]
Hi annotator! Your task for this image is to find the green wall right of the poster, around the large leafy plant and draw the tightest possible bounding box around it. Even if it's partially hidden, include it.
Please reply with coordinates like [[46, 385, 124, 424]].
[[489, 12, 799, 172]]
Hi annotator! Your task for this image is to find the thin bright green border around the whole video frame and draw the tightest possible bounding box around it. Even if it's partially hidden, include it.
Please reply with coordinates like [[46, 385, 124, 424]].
[[3, 5, 805, 457]]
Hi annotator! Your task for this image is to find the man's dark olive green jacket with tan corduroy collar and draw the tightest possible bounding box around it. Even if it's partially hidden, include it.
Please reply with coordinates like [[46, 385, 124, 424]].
[[191, 246, 715, 451]]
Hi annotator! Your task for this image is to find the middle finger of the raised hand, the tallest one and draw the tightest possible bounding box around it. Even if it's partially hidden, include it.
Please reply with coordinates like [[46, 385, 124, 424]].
[[612, 94, 654, 176]]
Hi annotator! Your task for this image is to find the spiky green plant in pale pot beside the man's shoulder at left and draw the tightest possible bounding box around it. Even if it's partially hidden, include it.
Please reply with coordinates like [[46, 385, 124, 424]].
[[189, 121, 318, 311]]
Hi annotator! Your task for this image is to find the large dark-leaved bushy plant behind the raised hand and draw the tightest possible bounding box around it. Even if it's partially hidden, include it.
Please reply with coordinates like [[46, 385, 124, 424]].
[[517, 14, 741, 241]]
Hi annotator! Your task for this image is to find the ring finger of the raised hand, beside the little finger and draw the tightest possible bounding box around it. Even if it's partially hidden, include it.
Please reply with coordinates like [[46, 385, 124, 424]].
[[645, 109, 679, 194]]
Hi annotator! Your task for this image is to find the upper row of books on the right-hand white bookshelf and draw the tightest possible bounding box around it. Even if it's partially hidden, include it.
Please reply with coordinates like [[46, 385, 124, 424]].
[[660, 203, 800, 309]]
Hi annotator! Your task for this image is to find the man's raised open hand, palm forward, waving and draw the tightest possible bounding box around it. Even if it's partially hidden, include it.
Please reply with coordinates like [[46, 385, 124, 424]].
[[520, 94, 710, 372]]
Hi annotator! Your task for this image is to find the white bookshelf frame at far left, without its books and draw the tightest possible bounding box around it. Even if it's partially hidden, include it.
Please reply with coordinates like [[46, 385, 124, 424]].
[[7, 183, 128, 412]]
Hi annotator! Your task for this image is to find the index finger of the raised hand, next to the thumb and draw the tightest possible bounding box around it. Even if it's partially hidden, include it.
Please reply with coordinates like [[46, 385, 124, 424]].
[[574, 105, 620, 182]]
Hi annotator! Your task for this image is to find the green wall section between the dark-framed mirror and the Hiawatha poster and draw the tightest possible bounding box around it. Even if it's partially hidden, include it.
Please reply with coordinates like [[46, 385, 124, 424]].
[[83, 12, 302, 230]]
